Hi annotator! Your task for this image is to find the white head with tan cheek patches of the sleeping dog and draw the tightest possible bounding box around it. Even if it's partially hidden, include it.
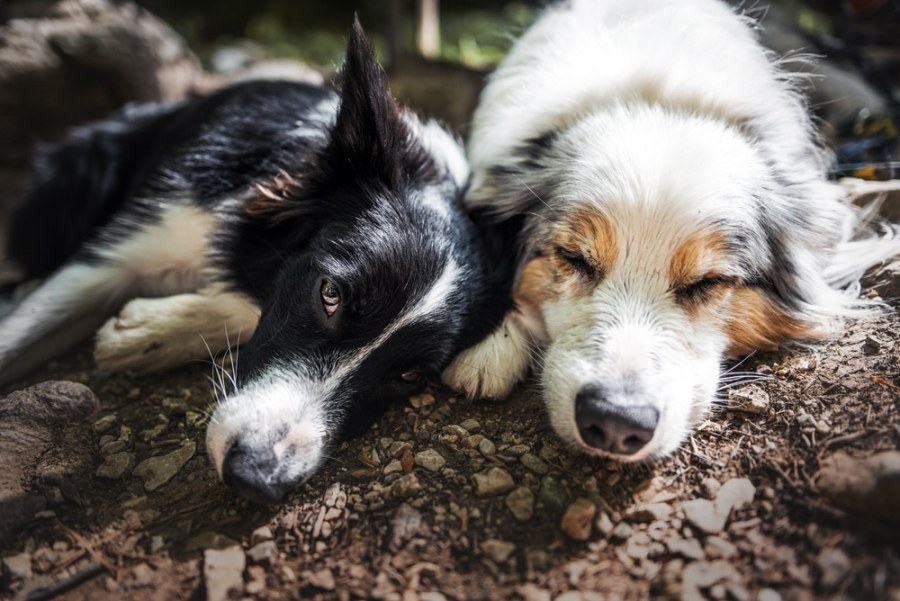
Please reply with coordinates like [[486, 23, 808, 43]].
[[475, 102, 897, 461]]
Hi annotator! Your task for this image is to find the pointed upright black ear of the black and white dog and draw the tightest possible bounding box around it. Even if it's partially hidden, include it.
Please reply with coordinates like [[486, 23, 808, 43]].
[[326, 17, 410, 187]]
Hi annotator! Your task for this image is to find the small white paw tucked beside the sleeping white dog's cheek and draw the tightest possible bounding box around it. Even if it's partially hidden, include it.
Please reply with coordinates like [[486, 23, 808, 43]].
[[441, 318, 531, 399]]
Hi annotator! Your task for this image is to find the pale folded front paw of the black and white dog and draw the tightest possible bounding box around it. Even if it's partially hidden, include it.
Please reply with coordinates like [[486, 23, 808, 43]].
[[94, 298, 193, 372]]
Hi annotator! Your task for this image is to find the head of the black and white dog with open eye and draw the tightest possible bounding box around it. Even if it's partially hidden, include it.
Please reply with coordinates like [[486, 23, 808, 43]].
[[207, 23, 500, 502]]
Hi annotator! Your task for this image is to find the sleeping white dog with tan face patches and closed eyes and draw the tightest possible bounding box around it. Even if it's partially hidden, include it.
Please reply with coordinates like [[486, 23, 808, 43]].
[[444, 0, 900, 461]]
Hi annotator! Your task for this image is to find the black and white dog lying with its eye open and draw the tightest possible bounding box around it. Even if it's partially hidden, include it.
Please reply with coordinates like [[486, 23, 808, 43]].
[[0, 23, 509, 502]]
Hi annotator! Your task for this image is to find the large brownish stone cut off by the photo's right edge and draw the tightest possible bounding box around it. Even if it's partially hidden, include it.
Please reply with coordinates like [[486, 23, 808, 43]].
[[816, 451, 900, 525]]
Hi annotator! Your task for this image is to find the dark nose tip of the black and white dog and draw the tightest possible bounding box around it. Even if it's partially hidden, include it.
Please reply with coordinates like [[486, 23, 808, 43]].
[[222, 442, 295, 505]]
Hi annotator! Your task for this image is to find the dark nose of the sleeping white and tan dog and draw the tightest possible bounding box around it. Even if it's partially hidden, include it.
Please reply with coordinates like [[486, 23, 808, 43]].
[[575, 386, 659, 455]]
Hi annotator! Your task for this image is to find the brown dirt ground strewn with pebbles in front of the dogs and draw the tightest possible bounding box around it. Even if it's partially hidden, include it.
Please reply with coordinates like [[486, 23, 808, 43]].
[[0, 255, 900, 601]]
